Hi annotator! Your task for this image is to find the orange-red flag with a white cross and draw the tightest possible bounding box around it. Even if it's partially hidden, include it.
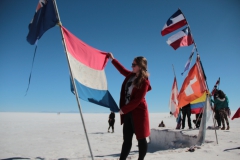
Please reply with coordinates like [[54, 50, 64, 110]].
[[178, 58, 207, 108]]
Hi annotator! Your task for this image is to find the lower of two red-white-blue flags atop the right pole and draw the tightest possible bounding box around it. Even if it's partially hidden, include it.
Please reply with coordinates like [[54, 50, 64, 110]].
[[167, 27, 193, 50]]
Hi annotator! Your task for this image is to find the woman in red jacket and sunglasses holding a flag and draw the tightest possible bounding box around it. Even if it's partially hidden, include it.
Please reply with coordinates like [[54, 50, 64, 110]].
[[109, 53, 151, 160]]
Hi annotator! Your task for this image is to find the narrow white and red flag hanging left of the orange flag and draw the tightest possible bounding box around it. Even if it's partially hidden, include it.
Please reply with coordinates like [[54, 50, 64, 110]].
[[169, 77, 179, 118]]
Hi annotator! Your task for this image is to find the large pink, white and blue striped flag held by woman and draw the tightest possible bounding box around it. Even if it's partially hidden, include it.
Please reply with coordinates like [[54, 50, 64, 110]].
[[62, 27, 119, 112]]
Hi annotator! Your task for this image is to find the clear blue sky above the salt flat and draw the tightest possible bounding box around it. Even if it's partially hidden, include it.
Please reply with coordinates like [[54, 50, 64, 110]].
[[0, 0, 240, 112]]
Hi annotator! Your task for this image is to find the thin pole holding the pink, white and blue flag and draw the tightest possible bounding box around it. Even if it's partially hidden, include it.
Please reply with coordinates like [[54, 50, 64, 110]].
[[53, 0, 94, 160]]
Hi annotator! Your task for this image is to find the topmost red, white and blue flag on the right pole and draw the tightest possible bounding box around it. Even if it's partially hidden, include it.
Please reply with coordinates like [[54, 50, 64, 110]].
[[161, 9, 187, 36]]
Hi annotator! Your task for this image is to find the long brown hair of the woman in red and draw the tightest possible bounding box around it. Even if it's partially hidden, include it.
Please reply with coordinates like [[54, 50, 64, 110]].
[[133, 56, 148, 89]]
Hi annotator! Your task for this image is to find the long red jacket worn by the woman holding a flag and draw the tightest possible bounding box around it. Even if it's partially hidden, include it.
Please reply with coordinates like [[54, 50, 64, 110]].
[[112, 59, 151, 139]]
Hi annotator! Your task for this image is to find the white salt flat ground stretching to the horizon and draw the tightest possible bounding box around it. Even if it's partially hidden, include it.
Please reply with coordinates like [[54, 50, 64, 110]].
[[0, 112, 240, 160]]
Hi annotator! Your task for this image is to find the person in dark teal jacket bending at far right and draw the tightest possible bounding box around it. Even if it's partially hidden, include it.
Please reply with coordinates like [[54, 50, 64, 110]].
[[211, 90, 230, 130]]
